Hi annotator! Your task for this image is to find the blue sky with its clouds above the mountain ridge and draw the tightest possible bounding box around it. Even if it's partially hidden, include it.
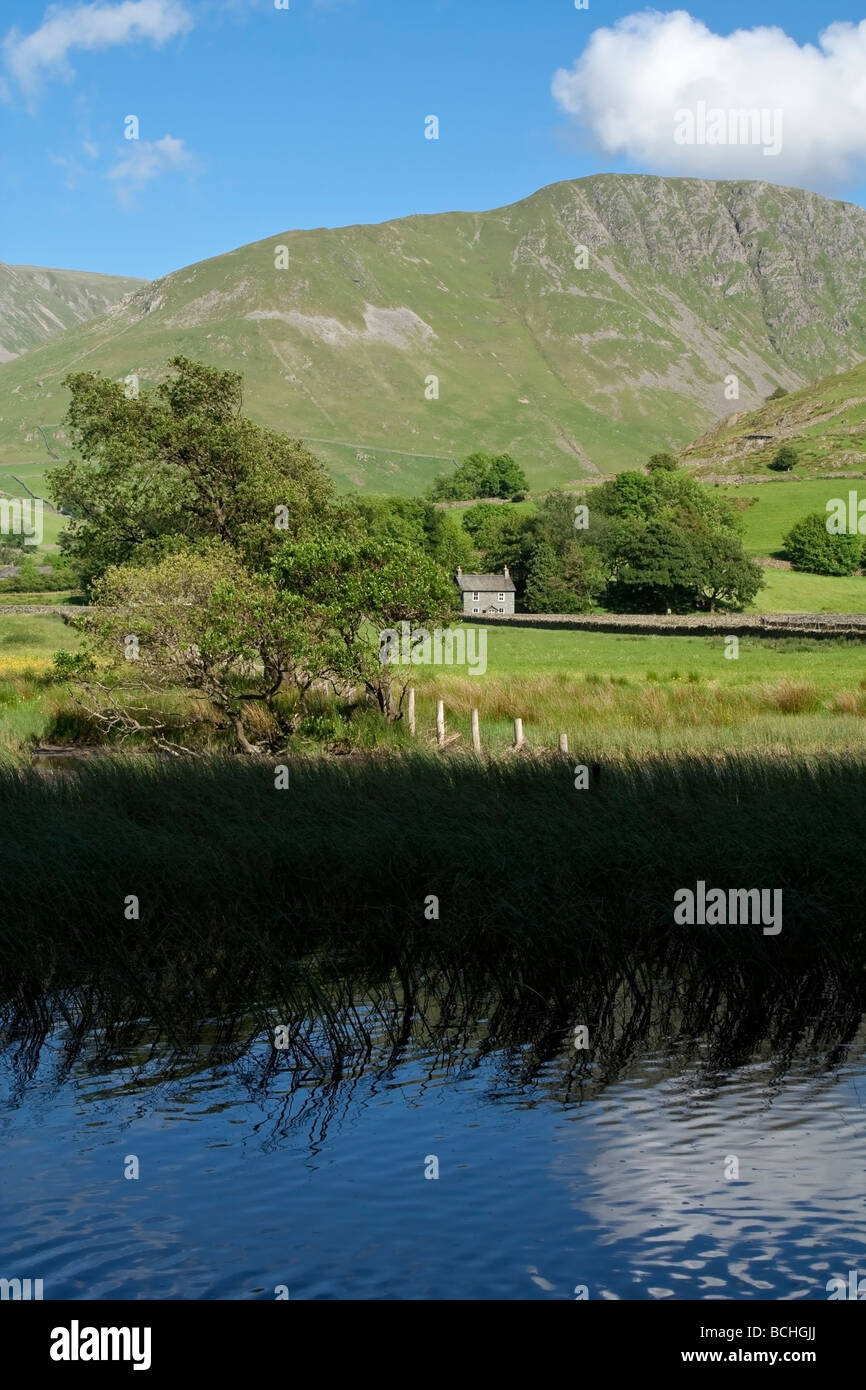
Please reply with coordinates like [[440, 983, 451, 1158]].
[[0, 0, 866, 278]]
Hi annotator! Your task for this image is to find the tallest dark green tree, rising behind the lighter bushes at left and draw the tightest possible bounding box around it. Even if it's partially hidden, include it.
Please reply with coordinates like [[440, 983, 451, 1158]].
[[50, 357, 332, 587]]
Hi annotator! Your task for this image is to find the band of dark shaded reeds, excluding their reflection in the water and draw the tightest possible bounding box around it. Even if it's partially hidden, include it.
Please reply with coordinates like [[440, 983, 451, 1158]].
[[0, 753, 866, 960]]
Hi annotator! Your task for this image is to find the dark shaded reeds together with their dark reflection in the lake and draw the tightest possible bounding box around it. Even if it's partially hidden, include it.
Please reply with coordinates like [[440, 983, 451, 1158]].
[[0, 753, 866, 1087]]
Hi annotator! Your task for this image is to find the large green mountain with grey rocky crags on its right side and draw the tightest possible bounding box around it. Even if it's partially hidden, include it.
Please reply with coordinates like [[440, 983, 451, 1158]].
[[0, 175, 866, 492]]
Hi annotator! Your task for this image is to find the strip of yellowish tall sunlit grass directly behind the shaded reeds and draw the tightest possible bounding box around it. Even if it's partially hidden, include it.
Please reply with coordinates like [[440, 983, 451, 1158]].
[[0, 669, 866, 756]]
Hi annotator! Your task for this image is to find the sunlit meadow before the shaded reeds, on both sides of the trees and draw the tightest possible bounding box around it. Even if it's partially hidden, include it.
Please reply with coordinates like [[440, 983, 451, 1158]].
[[0, 613, 866, 758]]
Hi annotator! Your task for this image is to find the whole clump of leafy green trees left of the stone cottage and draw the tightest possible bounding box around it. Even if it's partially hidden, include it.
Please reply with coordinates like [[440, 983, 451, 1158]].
[[54, 357, 471, 752]]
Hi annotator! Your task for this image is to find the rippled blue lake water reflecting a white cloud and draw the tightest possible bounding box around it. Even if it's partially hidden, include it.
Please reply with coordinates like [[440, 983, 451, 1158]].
[[0, 989, 866, 1300]]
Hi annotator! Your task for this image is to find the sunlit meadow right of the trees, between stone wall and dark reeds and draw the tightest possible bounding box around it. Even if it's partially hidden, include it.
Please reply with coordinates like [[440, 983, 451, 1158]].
[[416, 628, 866, 756]]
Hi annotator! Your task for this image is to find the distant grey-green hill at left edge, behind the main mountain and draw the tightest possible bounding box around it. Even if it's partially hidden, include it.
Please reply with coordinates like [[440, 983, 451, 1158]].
[[0, 261, 146, 361]]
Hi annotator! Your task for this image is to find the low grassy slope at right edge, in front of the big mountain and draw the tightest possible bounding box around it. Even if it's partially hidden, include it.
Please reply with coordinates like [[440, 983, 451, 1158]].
[[680, 363, 866, 480]]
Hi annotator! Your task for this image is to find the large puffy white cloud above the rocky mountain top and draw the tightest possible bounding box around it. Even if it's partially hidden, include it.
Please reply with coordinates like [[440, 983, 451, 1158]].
[[552, 10, 866, 186]]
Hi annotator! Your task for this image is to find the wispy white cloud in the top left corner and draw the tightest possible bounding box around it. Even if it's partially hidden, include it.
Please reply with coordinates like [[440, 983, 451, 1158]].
[[3, 0, 193, 99]]
